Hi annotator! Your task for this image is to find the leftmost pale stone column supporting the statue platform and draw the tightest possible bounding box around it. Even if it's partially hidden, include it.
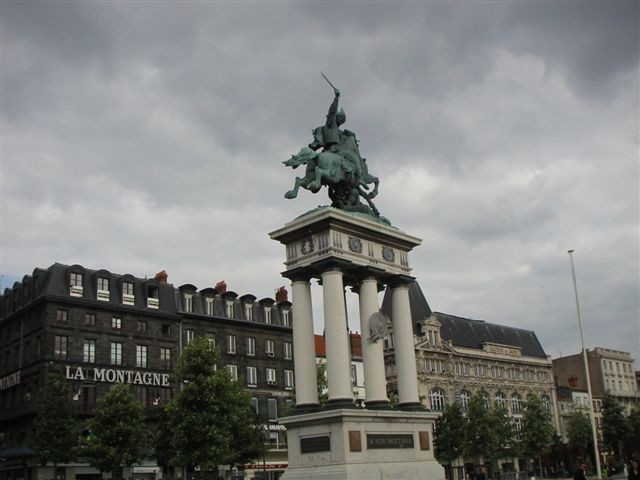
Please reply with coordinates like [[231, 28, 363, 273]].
[[291, 279, 318, 410]]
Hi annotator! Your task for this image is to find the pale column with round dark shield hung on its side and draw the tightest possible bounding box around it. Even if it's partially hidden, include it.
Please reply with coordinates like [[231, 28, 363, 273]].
[[359, 278, 389, 408]]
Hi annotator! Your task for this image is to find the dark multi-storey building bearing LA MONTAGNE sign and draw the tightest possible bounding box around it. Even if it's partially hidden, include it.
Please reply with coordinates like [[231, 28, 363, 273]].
[[0, 264, 294, 480]]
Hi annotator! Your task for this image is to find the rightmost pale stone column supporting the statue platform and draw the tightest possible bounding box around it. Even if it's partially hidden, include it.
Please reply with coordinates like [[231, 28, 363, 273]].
[[391, 283, 422, 409]]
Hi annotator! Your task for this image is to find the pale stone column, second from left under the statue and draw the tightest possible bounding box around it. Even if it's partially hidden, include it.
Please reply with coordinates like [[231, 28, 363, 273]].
[[322, 269, 353, 408]]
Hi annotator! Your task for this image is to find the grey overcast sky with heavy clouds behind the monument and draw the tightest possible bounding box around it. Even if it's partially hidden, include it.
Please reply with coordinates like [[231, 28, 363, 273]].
[[0, 0, 640, 365]]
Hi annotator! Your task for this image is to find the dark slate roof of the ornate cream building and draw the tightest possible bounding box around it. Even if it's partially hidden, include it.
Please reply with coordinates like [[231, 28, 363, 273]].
[[381, 282, 547, 358]]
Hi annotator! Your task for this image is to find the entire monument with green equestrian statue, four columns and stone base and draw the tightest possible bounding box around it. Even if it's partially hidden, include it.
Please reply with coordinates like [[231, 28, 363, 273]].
[[270, 77, 444, 480]]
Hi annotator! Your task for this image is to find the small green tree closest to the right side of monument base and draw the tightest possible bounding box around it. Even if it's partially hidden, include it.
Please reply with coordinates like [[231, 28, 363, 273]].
[[433, 403, 466, 479]]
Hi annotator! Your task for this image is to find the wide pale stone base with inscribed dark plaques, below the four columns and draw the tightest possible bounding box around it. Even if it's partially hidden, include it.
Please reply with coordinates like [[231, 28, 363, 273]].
[[280, 409, 444, 480]]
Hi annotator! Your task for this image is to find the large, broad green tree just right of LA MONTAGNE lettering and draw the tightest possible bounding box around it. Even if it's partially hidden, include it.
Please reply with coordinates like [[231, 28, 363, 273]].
[[163, 338, 265, 471]]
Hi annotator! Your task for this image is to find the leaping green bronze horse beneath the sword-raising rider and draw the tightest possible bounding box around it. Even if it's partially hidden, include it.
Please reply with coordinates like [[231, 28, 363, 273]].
[[282, 147, 380, 217]]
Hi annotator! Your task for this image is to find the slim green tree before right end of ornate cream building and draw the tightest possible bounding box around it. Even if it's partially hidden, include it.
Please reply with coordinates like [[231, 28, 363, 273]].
[[520, 395, 556, 474]]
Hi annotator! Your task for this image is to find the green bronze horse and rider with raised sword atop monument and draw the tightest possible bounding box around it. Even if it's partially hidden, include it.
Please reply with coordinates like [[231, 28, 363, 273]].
[[283, 74, 389, 224]]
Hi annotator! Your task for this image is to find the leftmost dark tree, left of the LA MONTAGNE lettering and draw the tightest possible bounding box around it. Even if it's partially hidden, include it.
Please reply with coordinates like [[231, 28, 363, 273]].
[[29, 373, 78, 466]]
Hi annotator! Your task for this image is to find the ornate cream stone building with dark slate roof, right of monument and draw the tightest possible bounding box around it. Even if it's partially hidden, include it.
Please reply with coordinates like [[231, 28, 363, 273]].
[[382, 282, 558, 475]]
